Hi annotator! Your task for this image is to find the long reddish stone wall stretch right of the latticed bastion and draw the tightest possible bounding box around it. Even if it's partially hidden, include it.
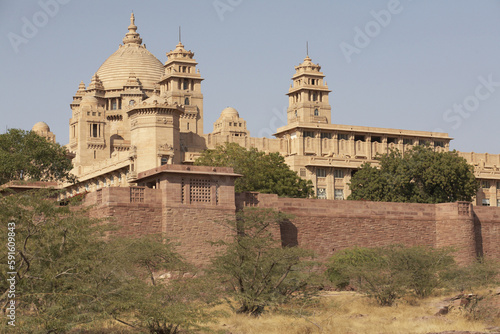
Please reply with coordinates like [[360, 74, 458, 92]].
[[236, 193, 500, 264]]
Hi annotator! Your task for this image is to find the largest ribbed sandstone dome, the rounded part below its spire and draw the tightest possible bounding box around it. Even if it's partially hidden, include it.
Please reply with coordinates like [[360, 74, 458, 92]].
[[97, 43, 164, 90]]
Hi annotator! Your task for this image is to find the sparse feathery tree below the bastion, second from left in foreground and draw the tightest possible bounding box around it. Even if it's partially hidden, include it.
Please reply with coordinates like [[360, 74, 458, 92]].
[[108, 236, 219, 334]]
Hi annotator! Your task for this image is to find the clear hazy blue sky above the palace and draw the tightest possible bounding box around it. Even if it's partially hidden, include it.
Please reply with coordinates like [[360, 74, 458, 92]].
[[0, 0, 500, 154]]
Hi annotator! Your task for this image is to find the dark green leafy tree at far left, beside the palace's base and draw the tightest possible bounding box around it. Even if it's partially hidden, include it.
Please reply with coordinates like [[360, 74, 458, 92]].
[[0, 129, 75, 184]]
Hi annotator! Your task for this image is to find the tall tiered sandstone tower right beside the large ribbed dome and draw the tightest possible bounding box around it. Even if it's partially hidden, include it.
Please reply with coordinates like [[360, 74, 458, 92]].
[[159, 41, 203, 136]]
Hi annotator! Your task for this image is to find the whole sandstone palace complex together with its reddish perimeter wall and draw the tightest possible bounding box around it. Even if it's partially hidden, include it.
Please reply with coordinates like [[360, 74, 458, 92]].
[[25, 14, 500, 262]]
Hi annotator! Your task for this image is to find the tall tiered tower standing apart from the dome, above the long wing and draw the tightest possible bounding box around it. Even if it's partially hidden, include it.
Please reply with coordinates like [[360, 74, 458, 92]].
[[287, 55, 331, 124]]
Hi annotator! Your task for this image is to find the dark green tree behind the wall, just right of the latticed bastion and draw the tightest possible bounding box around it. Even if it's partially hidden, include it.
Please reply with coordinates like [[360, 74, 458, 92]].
[[195, 143, 313, 198]]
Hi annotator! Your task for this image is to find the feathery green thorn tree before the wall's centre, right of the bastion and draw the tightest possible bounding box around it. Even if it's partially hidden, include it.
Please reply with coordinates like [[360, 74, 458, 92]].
[[213, 208, 313, 316]]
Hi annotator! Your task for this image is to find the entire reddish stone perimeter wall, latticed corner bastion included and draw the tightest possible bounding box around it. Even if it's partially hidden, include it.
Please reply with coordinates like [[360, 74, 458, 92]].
[[86, 187, 500, 265]]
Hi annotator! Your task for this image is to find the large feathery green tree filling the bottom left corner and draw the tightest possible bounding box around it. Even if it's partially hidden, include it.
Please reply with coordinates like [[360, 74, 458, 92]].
[[0, 190, 110, 333]]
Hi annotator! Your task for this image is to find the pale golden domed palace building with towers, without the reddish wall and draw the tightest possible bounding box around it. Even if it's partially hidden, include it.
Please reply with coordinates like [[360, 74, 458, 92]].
[[33, 14, 500, 206]]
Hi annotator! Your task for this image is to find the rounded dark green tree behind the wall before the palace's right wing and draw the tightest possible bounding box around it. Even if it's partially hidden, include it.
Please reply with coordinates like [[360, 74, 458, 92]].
[[348, 146, 478, 203]]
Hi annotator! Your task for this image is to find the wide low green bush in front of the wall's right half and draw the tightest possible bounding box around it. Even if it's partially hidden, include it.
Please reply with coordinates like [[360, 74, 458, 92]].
[[327, 245, 455, 306]]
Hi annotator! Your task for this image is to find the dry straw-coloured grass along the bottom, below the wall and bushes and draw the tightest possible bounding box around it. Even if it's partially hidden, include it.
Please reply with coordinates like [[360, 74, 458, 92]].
[[206, 292, 500, 334]]
